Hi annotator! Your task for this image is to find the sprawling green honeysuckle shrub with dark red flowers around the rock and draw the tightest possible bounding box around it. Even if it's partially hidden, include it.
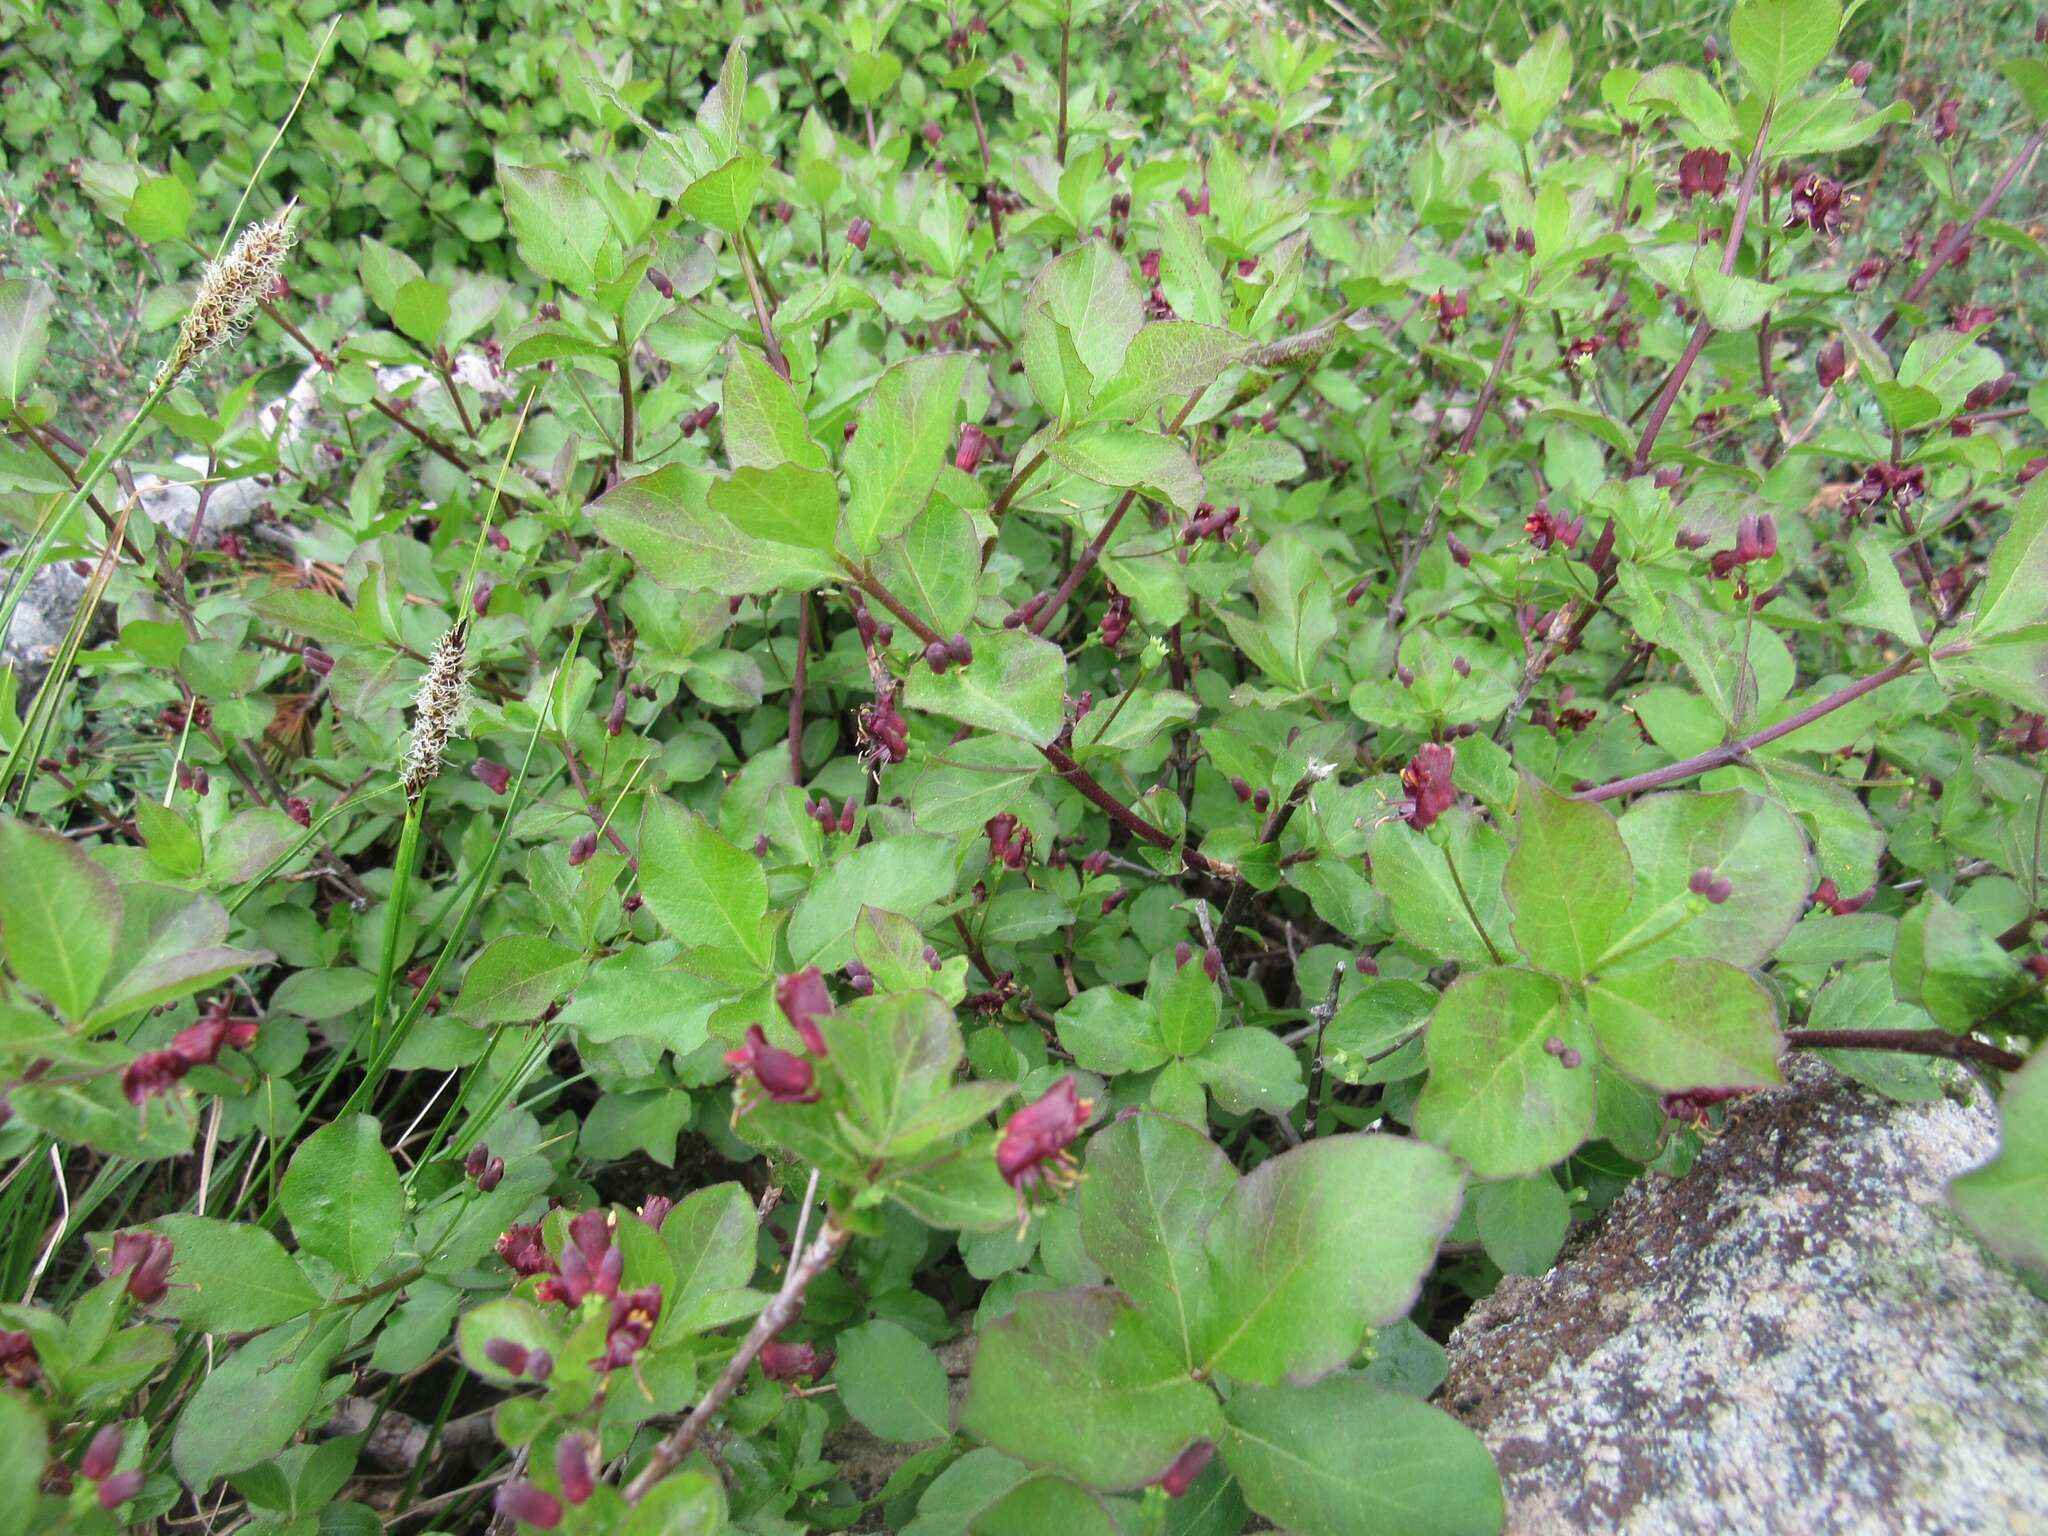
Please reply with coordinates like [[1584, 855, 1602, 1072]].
[[0, 0, 2048, 1536]]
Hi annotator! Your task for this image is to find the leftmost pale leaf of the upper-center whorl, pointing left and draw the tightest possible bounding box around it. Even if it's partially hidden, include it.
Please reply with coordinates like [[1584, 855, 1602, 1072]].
[[590, 465, 840, 598]]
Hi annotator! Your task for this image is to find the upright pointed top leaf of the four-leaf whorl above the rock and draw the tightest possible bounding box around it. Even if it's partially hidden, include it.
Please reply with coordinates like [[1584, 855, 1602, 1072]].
[[1503, 776, 1634, 981]]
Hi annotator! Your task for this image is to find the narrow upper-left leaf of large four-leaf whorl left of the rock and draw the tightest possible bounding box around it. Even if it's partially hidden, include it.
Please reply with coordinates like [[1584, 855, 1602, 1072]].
[[1079, 1112, 1237, 1366]]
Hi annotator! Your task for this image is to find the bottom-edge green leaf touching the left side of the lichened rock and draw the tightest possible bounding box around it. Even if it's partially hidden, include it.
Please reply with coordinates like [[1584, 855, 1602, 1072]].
[[1223, 1374, 1505, 1536]]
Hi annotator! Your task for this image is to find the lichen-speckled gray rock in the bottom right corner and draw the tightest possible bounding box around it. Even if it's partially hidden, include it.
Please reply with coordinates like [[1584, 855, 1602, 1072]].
[[1440, 1059, 2048, 1536]]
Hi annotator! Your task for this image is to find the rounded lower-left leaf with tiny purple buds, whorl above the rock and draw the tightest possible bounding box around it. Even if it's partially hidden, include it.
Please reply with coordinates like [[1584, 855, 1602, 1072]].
[[1413, 969, 1595, 1178]]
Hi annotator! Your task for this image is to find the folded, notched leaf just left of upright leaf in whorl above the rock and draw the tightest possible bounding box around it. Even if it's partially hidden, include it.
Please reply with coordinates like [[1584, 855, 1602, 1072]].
[[1372, 809, 1507, 965]]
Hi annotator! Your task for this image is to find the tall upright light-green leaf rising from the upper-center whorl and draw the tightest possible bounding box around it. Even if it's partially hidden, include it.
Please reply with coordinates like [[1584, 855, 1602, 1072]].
[[840, 352, 967, 555]]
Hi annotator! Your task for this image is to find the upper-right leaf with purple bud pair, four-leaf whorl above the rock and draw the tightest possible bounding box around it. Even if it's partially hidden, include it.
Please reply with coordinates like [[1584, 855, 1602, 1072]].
[[1604, 793, 1815, 969]]
